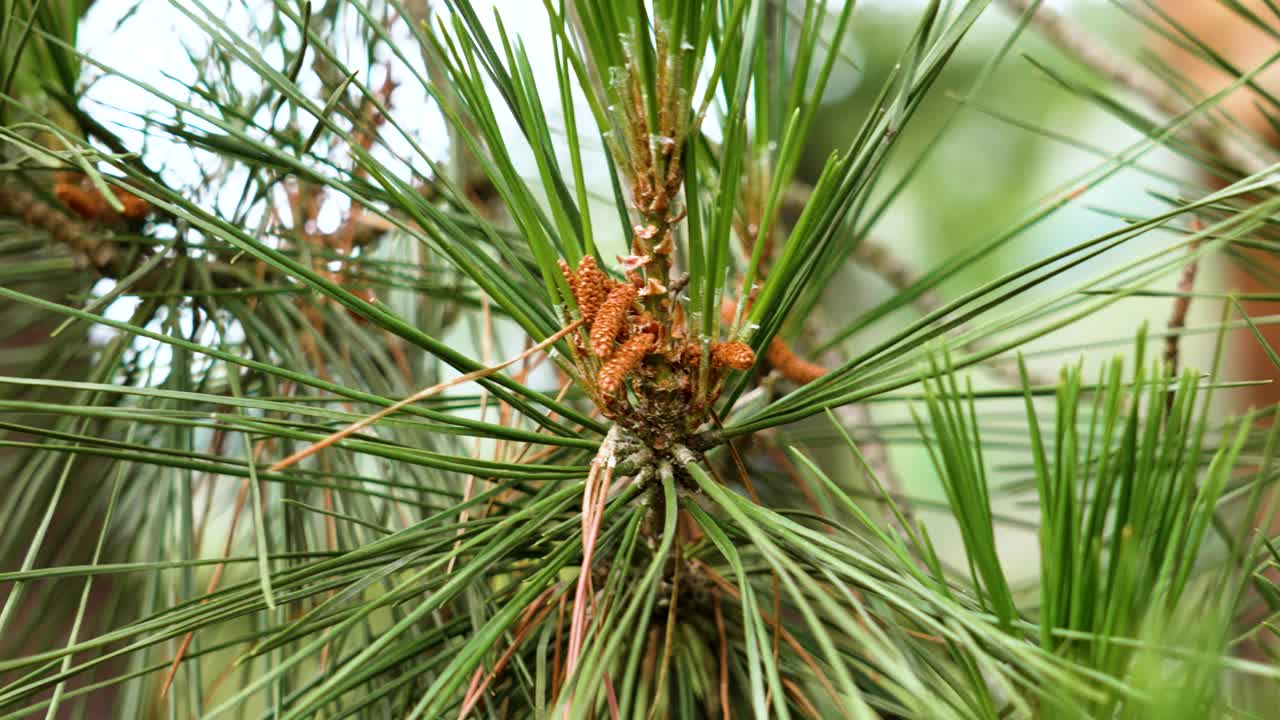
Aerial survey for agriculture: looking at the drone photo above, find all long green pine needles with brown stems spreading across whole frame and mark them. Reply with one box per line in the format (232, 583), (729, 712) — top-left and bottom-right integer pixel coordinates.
(0, 0), (1280, 719)
